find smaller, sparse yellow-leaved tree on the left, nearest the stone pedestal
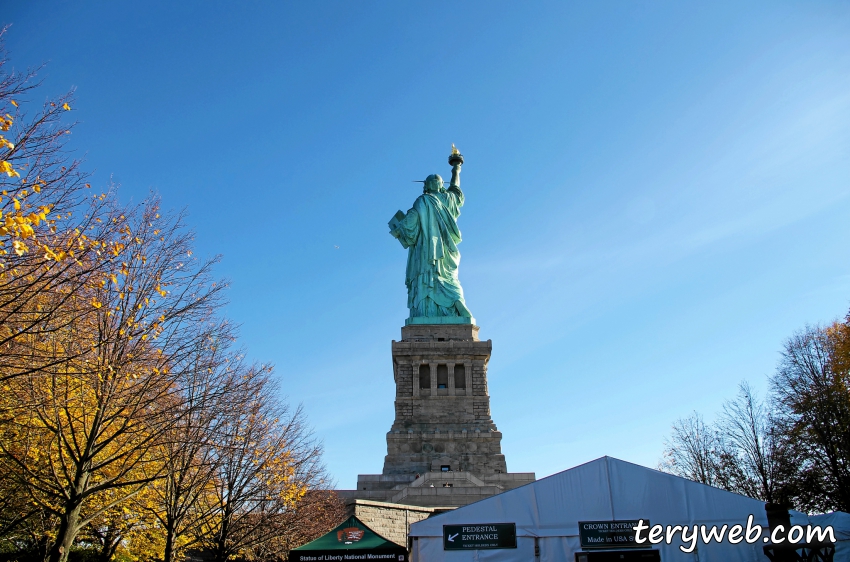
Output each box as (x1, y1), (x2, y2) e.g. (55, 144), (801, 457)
(200, 366), (326, 562)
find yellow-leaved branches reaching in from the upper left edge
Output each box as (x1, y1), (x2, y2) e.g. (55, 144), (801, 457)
(0, 26), (132, 388)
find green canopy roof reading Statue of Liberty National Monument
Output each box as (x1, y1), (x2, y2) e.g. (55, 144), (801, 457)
(289, 515), (407, 562)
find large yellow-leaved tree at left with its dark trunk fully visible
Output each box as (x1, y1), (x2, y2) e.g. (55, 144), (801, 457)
(0, 200), (223, 562)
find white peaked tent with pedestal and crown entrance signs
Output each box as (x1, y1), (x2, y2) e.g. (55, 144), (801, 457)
(410, 457), (808, 562)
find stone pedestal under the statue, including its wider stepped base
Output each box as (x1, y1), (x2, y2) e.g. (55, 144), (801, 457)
(341, 324), (534, 506)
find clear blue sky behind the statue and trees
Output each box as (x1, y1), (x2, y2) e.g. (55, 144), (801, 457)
(2, 0), (850, 487)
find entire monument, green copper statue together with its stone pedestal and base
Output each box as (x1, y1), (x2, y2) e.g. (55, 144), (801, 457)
(339, 146), (534, 507)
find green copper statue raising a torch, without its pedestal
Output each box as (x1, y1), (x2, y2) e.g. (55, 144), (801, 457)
(389, 145), (475, 324)
